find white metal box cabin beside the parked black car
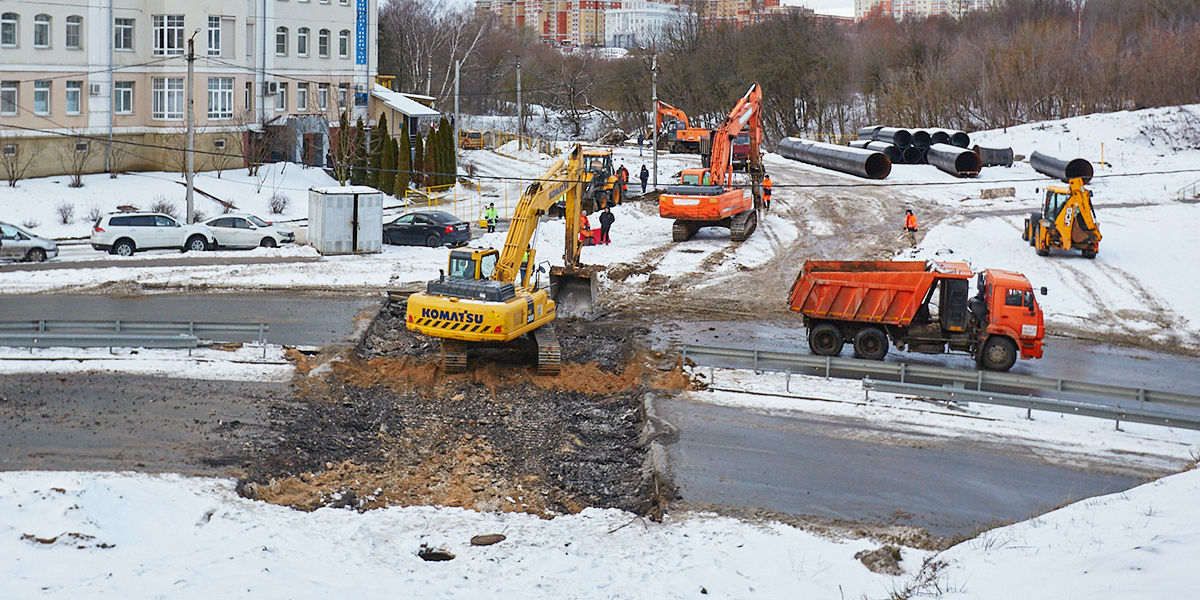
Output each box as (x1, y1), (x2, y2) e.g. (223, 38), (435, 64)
(308, 186), (383, 254)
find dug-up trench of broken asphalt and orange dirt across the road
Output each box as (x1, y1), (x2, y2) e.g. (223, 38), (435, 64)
(239, 310), (689, 517)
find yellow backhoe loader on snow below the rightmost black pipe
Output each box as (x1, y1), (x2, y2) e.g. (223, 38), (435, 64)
(1021, 178), (1100, 258)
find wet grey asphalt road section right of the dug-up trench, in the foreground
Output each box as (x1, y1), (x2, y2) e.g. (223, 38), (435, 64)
(658, 401), (1142, 538)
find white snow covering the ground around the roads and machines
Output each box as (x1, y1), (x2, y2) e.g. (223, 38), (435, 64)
(0, 107), (1200, 600)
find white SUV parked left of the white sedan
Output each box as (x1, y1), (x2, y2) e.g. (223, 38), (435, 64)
(91, 212), (216, 257)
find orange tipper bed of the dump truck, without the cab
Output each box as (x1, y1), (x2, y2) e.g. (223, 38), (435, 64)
(787, 260), (972, 326)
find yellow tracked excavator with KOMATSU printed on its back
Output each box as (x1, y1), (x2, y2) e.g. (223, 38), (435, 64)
(406, 144), (602, 374)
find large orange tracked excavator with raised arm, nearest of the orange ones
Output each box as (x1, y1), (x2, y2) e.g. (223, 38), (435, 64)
(659, 83), (763, 241)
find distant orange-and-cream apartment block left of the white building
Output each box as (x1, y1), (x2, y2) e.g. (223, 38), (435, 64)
(475, 0), (622, 46)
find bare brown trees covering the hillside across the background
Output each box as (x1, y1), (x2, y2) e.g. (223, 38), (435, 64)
(379, 0), (1200, 139)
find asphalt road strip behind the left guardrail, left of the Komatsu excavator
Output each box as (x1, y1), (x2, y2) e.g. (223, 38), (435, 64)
(0, 292), (383, 346)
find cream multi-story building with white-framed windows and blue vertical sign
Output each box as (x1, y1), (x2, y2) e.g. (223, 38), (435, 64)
(0, 0), (377, 176)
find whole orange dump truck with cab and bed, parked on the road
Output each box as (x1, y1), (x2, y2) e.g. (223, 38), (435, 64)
(787, 260), (1045, 371)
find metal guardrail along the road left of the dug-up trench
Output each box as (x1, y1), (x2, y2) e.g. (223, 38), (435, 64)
(0, 320), (270, 349)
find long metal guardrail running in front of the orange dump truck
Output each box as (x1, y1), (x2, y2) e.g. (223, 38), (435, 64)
(683, 344), (1200, 428)
